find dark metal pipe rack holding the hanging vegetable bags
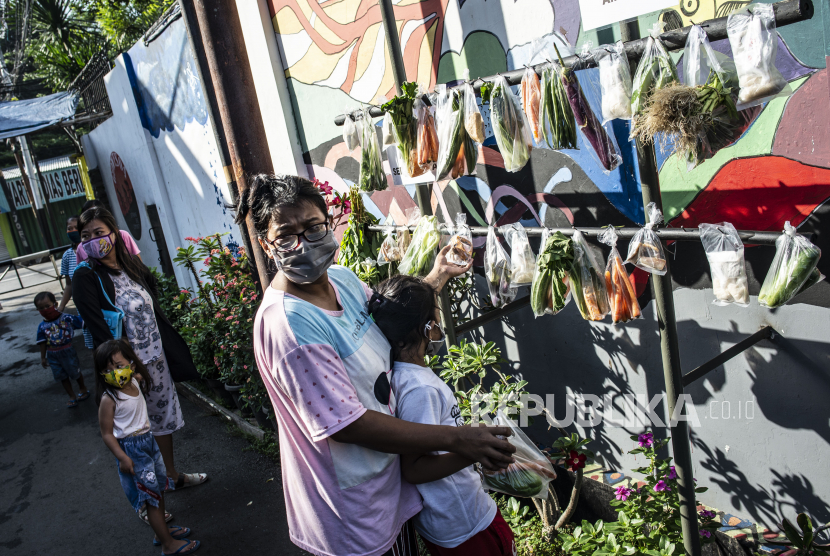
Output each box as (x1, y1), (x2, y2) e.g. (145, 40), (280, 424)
(348, 0), (814, 556)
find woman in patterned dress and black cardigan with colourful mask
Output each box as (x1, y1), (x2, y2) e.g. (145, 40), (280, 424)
(74, 207), (207, 524)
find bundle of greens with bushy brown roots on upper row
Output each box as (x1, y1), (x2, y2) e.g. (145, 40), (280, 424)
(631, 71), (741, 167)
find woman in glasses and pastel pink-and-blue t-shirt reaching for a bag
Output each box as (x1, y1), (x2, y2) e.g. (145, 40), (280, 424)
(236, 175), (515, 556)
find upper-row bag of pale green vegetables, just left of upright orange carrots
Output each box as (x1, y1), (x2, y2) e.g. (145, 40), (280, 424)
(490, 75), (533, 172)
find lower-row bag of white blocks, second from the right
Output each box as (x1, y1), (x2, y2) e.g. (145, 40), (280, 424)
(700, 222), (749, 307)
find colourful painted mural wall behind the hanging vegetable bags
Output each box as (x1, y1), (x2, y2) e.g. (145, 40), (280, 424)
(267, 0), (830, 527)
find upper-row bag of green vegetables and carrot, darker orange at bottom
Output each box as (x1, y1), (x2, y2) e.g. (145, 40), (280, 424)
(435, 85), (478, 180)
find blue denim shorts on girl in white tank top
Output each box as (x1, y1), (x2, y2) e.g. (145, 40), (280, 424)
(116, 432), (175, 512)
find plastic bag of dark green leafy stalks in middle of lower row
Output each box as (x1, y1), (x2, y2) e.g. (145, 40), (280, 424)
(530, 228), (574, 317)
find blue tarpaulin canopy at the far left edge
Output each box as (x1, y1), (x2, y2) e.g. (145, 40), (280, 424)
(0, 91), (79, 139)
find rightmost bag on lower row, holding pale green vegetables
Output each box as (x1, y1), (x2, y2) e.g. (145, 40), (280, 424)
(758, 221), (821, 309)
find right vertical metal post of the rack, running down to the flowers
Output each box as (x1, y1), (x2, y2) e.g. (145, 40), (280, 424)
(637, 140), (700, 556)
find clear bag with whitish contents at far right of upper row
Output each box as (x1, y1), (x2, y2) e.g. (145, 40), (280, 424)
(726, 4), (787, 110)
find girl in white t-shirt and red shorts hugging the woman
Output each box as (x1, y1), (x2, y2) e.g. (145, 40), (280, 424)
(369, 276), (516, 556)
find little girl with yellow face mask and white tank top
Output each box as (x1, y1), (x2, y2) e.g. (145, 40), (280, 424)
(95, 339), (200, 555)
